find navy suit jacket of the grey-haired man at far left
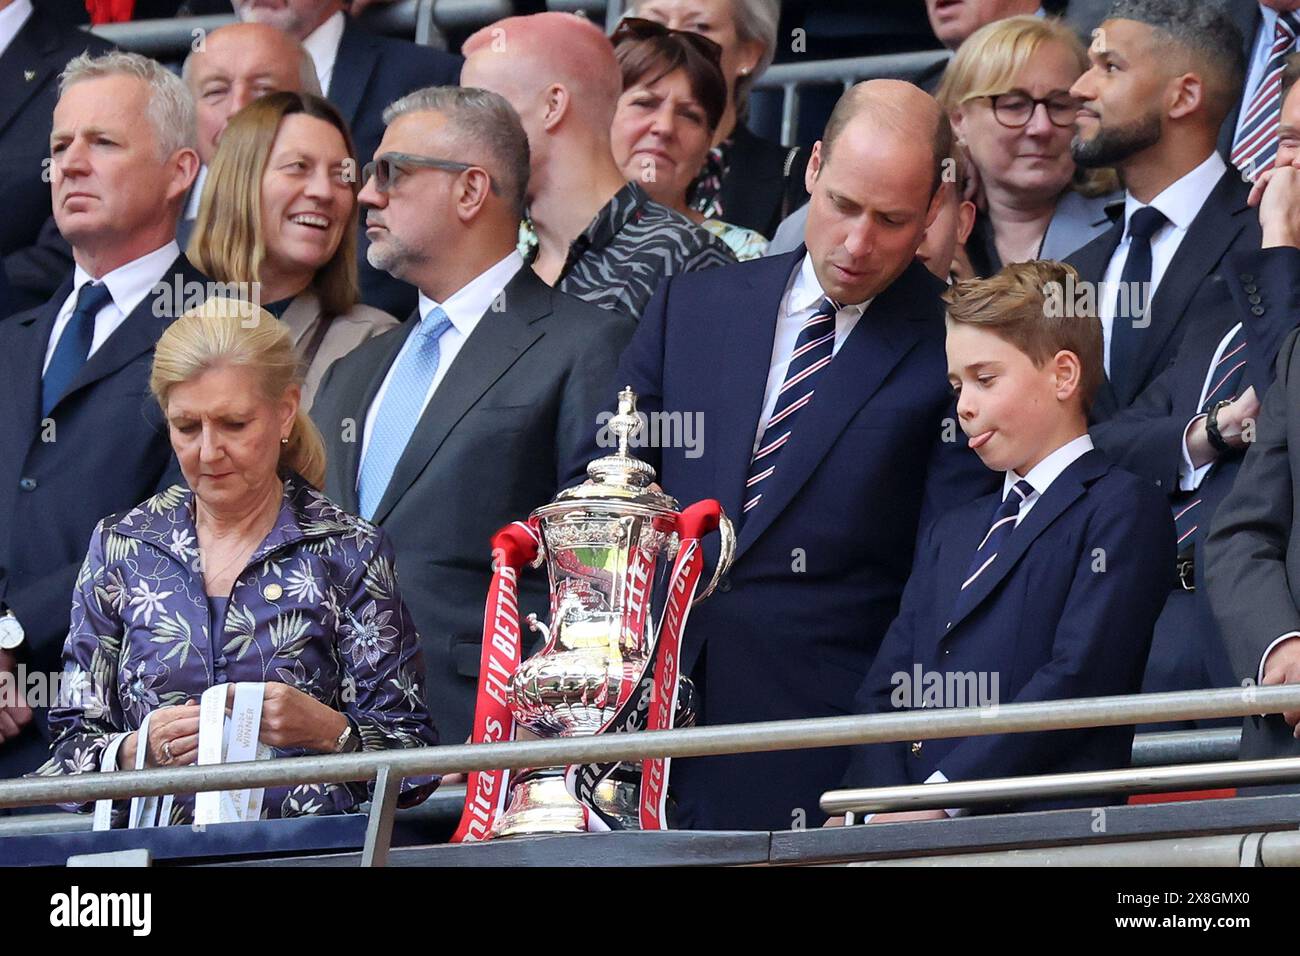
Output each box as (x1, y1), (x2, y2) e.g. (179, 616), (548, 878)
(0, 256), (196, 770)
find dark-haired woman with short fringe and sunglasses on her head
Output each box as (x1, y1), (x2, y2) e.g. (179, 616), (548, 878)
(610, 17), (767, 260)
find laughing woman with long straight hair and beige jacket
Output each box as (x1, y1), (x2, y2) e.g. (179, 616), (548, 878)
(187, 92), (398, 408)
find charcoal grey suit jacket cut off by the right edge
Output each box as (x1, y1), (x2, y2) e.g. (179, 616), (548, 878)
(1205, 325), (1300, 764)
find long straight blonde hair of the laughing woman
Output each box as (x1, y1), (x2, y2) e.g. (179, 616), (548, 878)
(186, 91), (360, 319)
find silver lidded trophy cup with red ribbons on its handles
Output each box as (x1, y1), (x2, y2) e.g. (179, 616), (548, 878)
(452, 388), (736, 842)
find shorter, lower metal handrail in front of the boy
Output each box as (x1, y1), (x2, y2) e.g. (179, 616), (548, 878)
(820, 757), (1300, 816)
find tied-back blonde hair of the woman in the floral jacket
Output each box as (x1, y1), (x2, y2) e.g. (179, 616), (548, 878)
(150, 295), (325, 489)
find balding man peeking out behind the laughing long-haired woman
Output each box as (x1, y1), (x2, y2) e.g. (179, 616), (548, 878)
(177, 23), (321, 248)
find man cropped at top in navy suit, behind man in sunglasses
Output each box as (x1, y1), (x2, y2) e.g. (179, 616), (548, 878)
(233, 0), (462, 315)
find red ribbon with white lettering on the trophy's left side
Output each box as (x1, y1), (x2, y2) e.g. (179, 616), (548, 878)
(451, 522), (541, 843)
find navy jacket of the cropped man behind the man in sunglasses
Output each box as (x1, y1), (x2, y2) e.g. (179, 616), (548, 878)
(329, 17), (462, 315)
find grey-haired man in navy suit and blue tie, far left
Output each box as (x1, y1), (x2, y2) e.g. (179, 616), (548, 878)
(0, 53), (203, 777)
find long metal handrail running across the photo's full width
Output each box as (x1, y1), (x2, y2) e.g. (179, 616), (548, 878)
(0, 684), (1300, 808)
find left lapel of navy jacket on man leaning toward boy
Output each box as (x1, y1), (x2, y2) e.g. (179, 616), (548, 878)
(709, 246), (805, 520)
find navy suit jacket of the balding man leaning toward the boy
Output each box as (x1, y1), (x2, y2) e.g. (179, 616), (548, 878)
(618, 248), (993, 830)
